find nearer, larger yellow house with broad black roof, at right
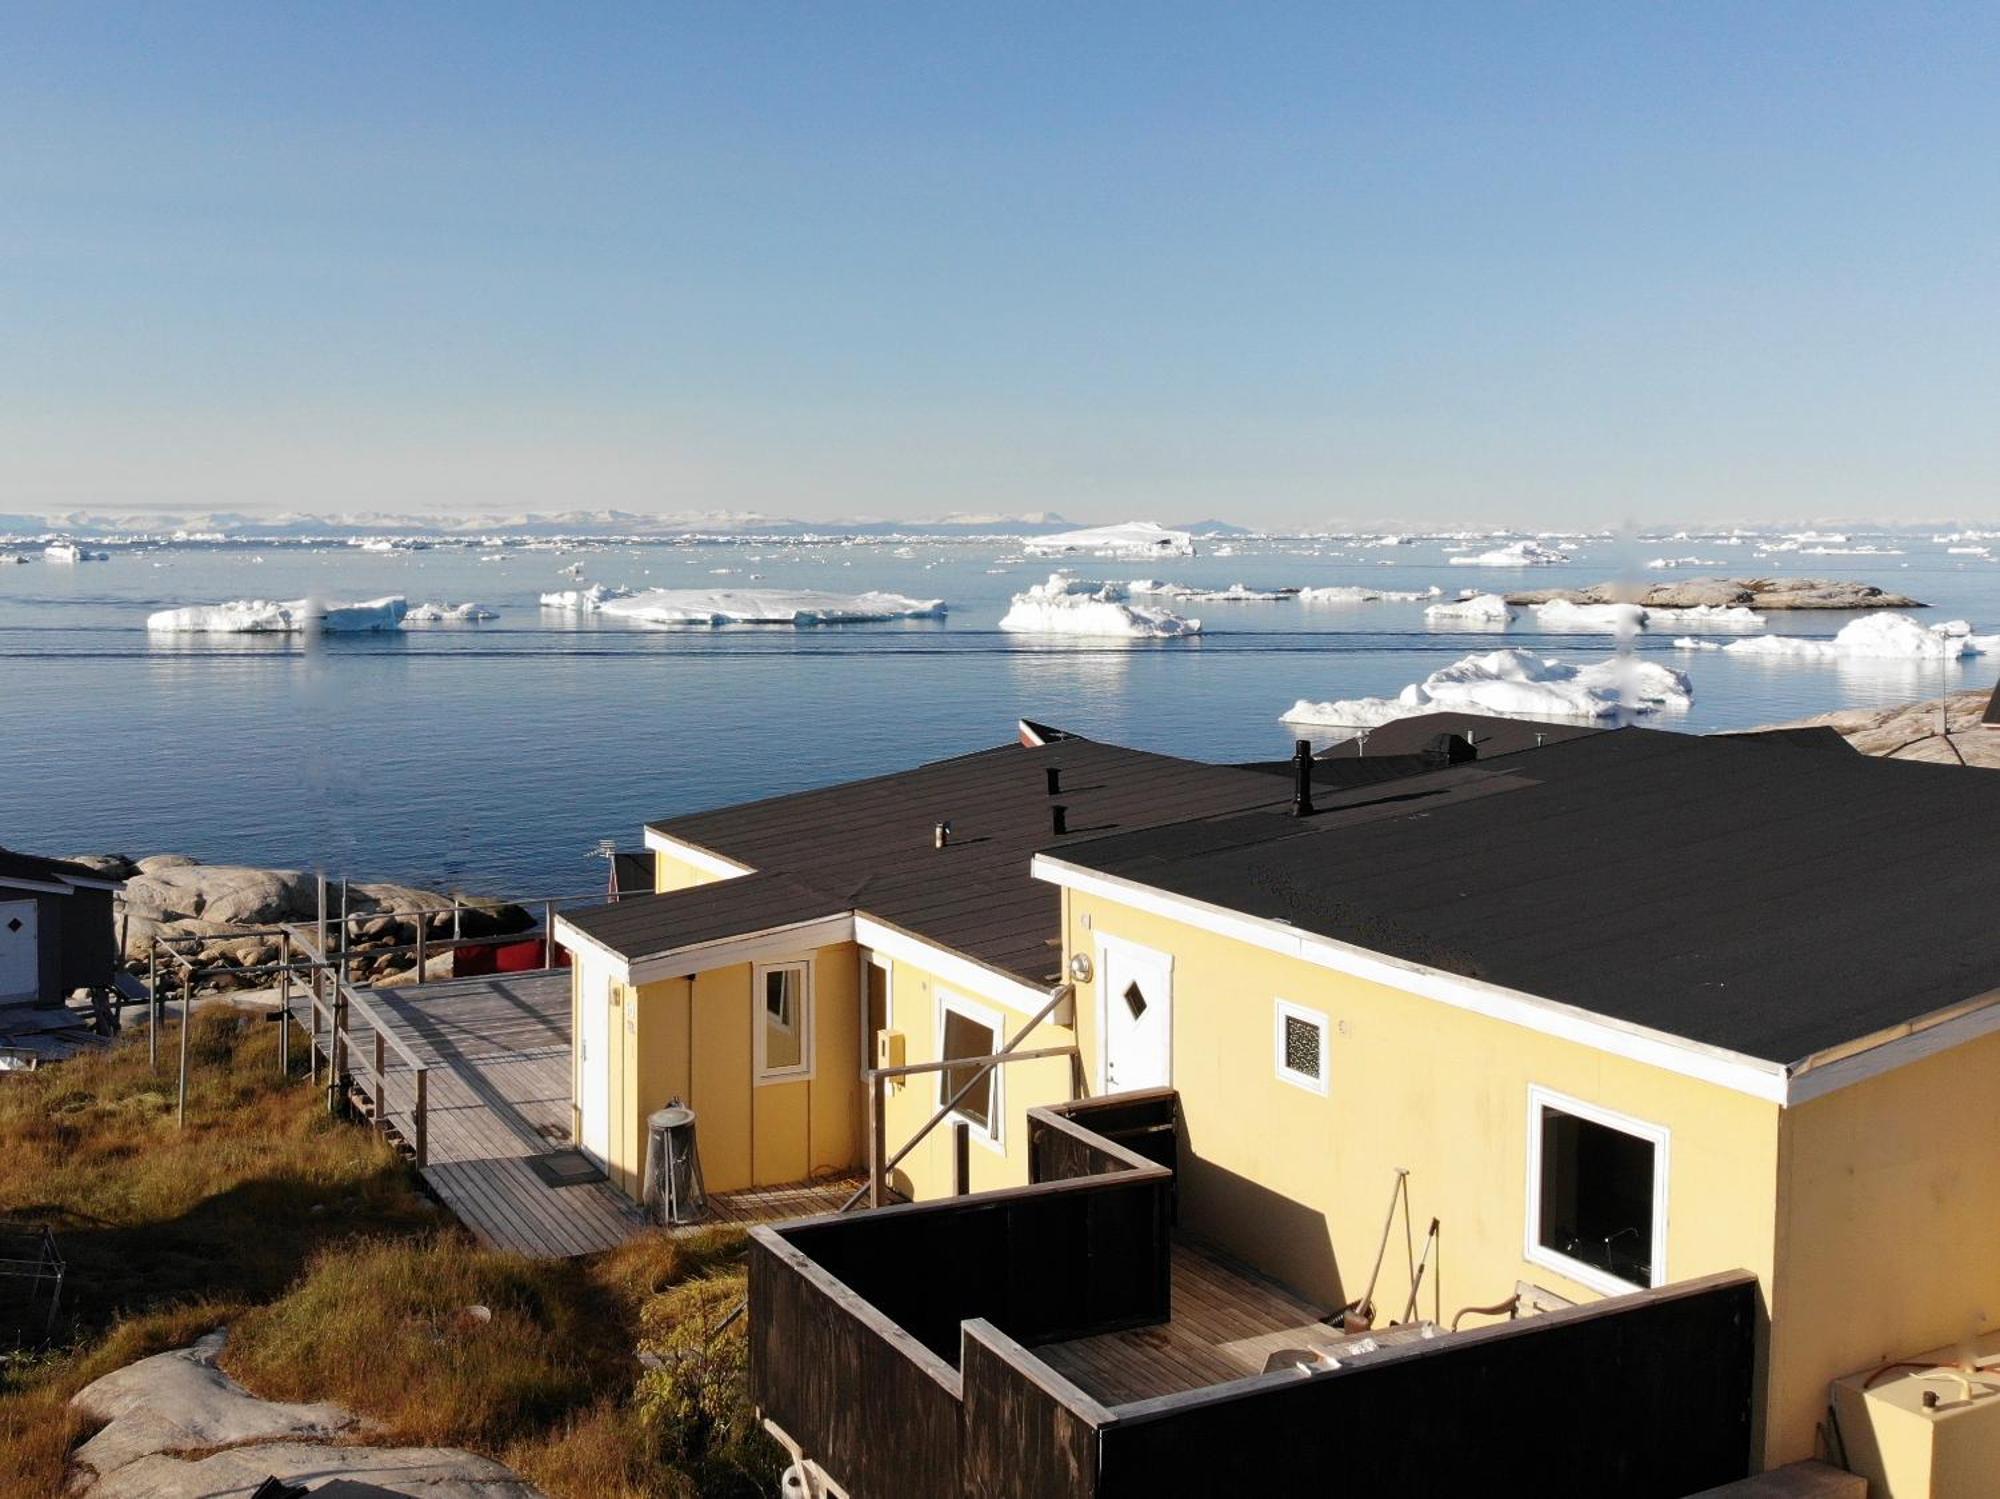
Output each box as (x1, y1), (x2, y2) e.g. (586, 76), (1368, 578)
(1034, 730), (2000, 1493)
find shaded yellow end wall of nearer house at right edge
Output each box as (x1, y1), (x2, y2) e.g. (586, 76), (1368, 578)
(1768, 1035), (2000, 1461)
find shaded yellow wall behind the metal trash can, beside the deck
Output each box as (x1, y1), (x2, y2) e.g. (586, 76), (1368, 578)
(610, 943), (862, 1195)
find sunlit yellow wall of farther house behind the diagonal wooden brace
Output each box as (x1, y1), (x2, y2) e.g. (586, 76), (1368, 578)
(862, 961), (1076, 1201)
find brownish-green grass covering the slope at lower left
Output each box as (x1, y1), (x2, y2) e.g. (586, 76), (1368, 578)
(0, 1007), (778, 1499)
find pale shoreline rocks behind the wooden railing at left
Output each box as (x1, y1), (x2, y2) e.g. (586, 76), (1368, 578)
(72, 853), (534, 989)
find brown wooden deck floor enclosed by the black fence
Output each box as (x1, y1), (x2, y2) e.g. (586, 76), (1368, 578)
(1034, 1241), (1342, 1405)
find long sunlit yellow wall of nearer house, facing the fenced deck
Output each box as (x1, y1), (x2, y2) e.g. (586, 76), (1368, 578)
(1066, 891), (1778, 1447)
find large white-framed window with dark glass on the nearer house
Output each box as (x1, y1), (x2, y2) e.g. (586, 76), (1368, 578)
(1526, 1087), (1672, 1295)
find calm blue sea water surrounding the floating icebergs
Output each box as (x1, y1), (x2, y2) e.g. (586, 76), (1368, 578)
(0, 532), (2000, 895)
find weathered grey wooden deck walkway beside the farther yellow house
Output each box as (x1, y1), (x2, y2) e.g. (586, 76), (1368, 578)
(354, 971), (862, 1259)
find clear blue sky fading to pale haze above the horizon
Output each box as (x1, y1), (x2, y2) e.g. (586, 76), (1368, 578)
(0, 0), (2000, 526)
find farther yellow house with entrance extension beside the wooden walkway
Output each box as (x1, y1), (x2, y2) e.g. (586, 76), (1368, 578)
(556, 726), (1286, 1201)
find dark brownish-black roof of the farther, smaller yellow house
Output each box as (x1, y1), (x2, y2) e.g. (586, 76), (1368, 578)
(566, 738), (1290, 985)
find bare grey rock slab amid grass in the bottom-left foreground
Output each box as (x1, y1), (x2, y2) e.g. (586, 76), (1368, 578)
(70, 1331), (546, 1499)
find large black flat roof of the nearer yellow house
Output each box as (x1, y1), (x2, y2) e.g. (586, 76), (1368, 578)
(1052, 730), (2000, 1065)
